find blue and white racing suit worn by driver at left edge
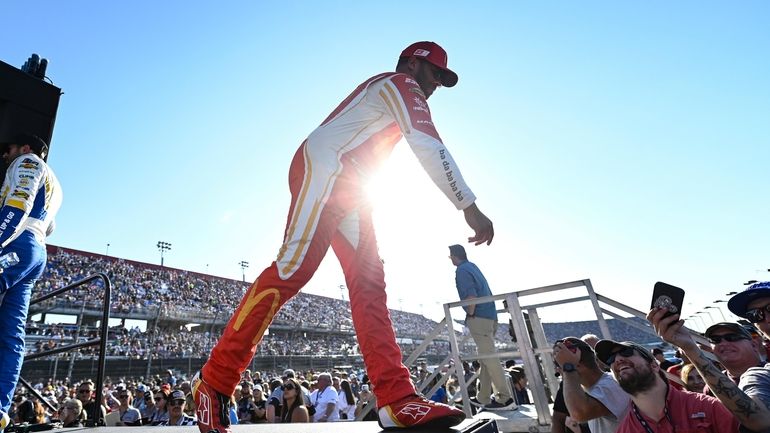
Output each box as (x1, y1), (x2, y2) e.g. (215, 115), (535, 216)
(0, 153), (62, 412)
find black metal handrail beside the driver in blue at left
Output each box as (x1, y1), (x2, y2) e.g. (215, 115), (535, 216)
(25, 272), (112, 427)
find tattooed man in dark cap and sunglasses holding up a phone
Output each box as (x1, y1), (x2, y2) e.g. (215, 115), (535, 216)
(647, 306), (770, 432)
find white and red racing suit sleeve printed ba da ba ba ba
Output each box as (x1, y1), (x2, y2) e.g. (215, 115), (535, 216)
(378, 74), (476, 210)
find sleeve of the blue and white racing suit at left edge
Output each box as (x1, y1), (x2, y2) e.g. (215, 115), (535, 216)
(0, 155), (44, 248)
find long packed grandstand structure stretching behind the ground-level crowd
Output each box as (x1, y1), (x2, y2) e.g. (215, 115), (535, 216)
(23, 245), (655, 380)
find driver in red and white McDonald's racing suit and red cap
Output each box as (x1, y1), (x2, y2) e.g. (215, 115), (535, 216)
(193, 42), (494, 433)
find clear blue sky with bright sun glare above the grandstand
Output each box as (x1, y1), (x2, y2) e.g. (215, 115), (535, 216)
(0, 0), (770, 328)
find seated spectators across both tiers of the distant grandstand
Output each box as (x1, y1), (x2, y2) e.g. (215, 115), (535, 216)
(27, 247), (664, 359)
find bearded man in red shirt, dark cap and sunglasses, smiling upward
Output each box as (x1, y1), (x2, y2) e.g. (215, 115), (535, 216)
(596, 340), (739, 433)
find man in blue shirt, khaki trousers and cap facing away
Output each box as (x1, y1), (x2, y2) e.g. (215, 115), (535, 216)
(449, 245), (517, 410)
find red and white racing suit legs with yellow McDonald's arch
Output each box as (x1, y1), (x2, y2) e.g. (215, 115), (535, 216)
(198, 145), (415, 406)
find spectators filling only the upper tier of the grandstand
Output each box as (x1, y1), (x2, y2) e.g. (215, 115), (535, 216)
(35, 247), (446, 337)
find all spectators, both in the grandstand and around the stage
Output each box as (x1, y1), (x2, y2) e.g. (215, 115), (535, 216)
(18, 250), (770, 433)
